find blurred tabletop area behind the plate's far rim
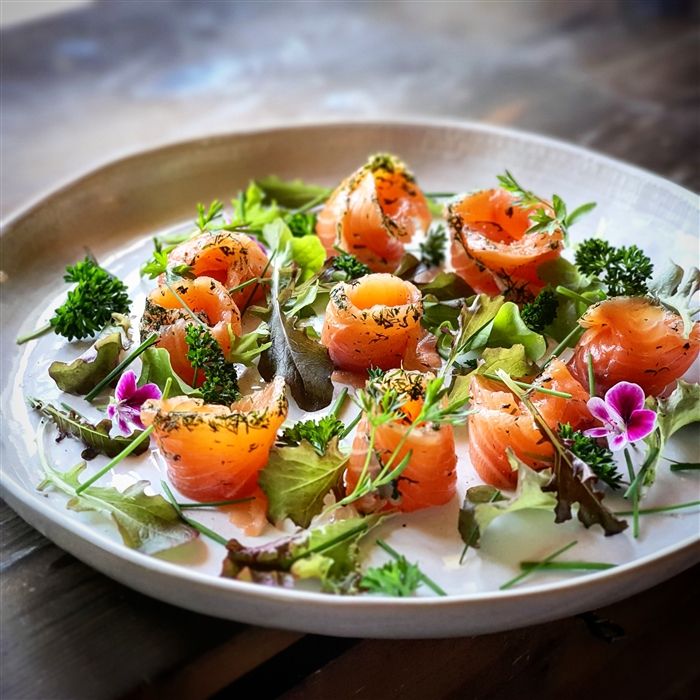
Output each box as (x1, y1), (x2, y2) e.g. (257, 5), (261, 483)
(0, 0), (700, 215)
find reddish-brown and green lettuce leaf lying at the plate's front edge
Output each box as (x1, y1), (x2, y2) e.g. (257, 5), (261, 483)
(221, 515), (381, 590)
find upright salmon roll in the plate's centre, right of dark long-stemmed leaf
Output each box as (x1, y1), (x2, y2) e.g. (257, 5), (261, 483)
(321, 273), (423, 372)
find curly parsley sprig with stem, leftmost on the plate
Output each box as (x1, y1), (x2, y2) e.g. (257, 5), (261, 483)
(17, 255), (131, 345)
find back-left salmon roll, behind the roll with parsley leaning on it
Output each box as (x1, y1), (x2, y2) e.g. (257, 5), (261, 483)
(165, 231), (270, 309)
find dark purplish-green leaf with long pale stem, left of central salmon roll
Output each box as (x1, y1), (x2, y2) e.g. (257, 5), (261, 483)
(258, 232), (333, 411)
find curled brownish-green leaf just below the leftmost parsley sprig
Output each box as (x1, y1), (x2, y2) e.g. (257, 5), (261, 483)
(49, 314), (130, 396)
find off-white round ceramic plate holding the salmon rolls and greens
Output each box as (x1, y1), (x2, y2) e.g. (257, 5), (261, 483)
(2, 122), (700, 637)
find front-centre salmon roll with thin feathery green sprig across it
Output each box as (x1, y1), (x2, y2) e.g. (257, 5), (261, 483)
(345, 369), (457, 513)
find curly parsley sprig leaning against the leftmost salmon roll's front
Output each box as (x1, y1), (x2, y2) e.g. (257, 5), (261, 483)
(185, 323), (241, 405)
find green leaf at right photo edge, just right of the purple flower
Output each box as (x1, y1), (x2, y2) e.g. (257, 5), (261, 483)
(640, 379), (700, 486)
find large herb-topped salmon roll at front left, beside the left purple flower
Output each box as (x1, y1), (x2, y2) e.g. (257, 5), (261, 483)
(141, 377), (287, 501)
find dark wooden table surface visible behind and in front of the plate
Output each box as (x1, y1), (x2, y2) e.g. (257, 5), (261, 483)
(0, 0), (700, 700)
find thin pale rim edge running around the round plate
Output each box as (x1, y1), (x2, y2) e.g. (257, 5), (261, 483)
(0, 117), (700, 620)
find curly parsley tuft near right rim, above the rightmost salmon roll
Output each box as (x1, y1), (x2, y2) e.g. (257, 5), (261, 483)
(575, 238), (654, 297)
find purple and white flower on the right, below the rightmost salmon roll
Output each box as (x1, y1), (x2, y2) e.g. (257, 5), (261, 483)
(585, 382), (656, 451)
